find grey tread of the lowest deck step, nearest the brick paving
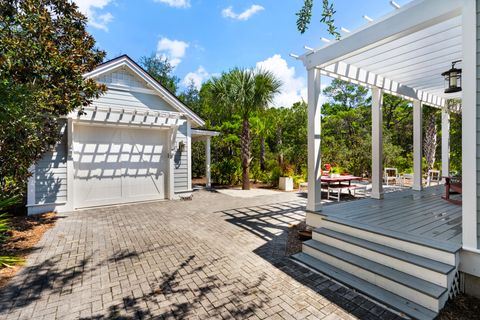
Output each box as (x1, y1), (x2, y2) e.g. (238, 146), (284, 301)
(292, 253), (437, 320)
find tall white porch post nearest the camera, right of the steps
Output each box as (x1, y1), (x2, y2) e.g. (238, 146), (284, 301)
(462, 1), (480, 250)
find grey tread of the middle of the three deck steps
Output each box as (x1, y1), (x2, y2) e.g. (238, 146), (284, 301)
(303, 240), (447, 299)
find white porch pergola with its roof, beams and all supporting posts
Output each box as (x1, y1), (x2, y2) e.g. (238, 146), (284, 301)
(298, 0), (477, 250)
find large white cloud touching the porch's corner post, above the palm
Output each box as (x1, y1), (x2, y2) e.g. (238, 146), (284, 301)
(256, 54), (307, 108)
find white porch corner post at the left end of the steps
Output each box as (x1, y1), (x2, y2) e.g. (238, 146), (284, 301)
(307, 69), (322, 211)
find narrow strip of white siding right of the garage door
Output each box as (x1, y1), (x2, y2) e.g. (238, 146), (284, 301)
(173, 122), (189, 192)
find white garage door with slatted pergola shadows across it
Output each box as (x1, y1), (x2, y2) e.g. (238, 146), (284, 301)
(73, 126), (168, 208)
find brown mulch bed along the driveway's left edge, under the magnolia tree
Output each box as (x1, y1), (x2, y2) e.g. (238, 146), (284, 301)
(0, 213), (57, 287)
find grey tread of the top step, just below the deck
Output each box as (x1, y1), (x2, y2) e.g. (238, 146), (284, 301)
(314, 228), (455, 274)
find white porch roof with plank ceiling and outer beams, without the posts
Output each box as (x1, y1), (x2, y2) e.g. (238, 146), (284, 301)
(300, 0), (463, 107)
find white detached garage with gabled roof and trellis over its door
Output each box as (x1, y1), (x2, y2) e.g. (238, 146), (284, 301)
(27, 55), (217, 214)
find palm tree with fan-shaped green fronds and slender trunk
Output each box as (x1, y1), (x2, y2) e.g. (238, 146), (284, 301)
(212, 68), (282, 190)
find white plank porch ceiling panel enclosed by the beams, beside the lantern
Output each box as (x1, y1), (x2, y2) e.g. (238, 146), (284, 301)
(343, 16), (462, 98)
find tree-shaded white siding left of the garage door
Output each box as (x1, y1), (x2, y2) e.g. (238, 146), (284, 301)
(35, 123), (67, 204)
